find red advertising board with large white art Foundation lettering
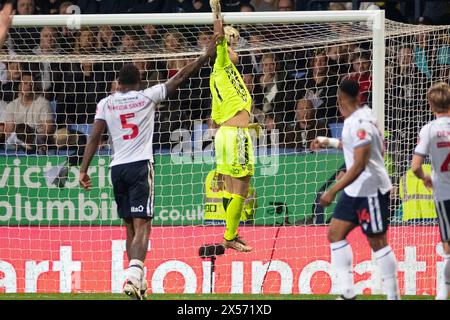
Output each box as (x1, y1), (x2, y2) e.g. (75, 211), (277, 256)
(0, 226), (443, 295)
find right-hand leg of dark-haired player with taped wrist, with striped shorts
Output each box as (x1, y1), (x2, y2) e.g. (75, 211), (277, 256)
(360, 192), (400, 300)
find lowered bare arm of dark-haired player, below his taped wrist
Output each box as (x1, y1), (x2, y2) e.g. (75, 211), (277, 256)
(320, 144), (370, 207)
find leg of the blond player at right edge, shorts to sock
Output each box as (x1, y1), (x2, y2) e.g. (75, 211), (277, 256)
(436, 200), (450, 300)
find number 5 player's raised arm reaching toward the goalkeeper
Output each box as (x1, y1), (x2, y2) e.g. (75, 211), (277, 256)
(166, 35), (218, 96)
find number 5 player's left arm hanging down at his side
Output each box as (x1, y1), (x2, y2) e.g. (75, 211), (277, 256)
(79, 120), (106, 190)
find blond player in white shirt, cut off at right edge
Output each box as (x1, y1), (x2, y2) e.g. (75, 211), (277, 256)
(412, 82), (450, 300)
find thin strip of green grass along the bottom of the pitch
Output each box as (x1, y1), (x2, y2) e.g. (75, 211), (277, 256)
(0, 293), (434, 300)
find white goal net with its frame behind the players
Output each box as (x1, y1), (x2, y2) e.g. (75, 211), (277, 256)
(0, 11), (450, 294)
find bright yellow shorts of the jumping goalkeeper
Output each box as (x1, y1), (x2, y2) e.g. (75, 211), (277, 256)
(214, 126), (255, 178)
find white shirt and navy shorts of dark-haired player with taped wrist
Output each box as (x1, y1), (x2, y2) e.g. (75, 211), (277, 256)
(333, 105), (392, 235)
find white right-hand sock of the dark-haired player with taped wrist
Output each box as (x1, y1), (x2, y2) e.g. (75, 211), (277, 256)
(374, 246), (400, 300)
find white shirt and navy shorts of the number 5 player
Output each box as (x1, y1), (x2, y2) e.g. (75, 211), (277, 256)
(95, 84), (167, 219)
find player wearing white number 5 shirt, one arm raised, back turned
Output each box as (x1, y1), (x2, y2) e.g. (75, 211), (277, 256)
(79, 37), (217, 300)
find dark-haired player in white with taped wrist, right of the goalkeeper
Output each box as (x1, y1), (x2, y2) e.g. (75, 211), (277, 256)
(311, 80), (400, 300)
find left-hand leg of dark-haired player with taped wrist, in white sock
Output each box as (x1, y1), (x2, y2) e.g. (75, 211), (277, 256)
(328, 215), (356, 300)
